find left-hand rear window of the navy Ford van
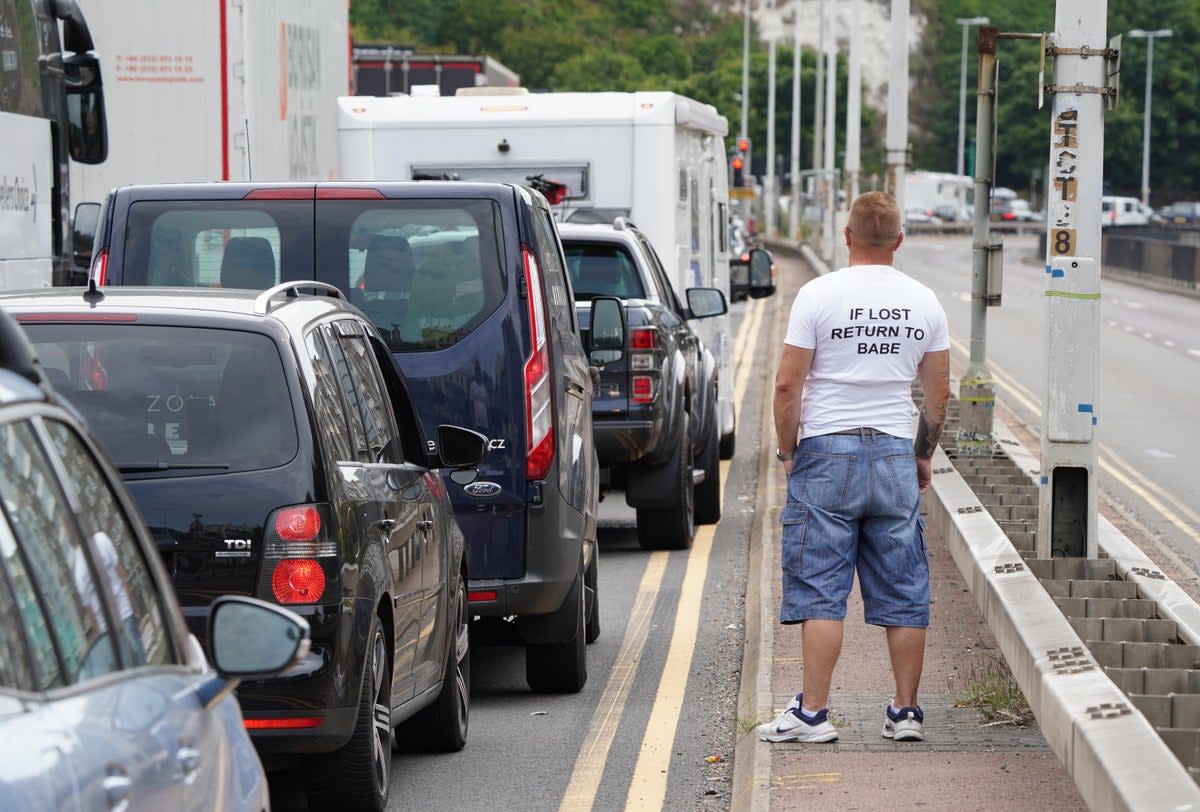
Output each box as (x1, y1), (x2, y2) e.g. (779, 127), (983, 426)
(119, 200), (313, 289)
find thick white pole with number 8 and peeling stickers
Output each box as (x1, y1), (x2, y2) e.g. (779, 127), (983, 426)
(1037, 0), (1112, 558)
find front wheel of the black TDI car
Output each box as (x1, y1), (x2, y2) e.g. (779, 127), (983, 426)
(403, 572), (470, 753)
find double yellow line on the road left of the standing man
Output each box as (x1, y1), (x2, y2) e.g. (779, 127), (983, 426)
(558, 300), (764, 812)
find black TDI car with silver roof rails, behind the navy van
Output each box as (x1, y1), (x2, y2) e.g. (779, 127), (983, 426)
(0, 282), (487, 810)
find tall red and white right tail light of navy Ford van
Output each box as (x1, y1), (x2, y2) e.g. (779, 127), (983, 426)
(521, 246), (554, 480)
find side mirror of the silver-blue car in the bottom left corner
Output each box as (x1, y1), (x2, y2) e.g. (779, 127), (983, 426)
(209, 595), (310, 679)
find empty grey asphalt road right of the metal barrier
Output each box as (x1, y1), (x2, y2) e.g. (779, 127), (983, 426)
(898, 235), (1200, 599)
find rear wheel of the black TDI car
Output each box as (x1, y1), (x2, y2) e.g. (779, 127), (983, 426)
(308, 615), (392, 812)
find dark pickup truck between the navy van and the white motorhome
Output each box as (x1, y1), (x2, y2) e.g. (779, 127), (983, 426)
(559, 217), (727, 549)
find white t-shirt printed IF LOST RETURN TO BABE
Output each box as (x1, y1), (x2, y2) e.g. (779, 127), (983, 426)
(784, 265), (950, 438)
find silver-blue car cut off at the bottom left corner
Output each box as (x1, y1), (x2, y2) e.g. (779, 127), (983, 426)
(0, 311), (310, 812)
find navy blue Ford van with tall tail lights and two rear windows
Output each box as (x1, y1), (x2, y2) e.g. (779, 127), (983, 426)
(81, 181), (600, 693)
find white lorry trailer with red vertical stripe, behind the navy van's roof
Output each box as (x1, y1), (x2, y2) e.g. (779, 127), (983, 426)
(71, 0), (350, 202)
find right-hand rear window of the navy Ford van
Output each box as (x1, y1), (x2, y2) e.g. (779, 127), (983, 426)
(316, 198), (508, 353)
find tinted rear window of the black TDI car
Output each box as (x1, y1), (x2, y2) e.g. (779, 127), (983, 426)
(23, 320), (298, 475)
